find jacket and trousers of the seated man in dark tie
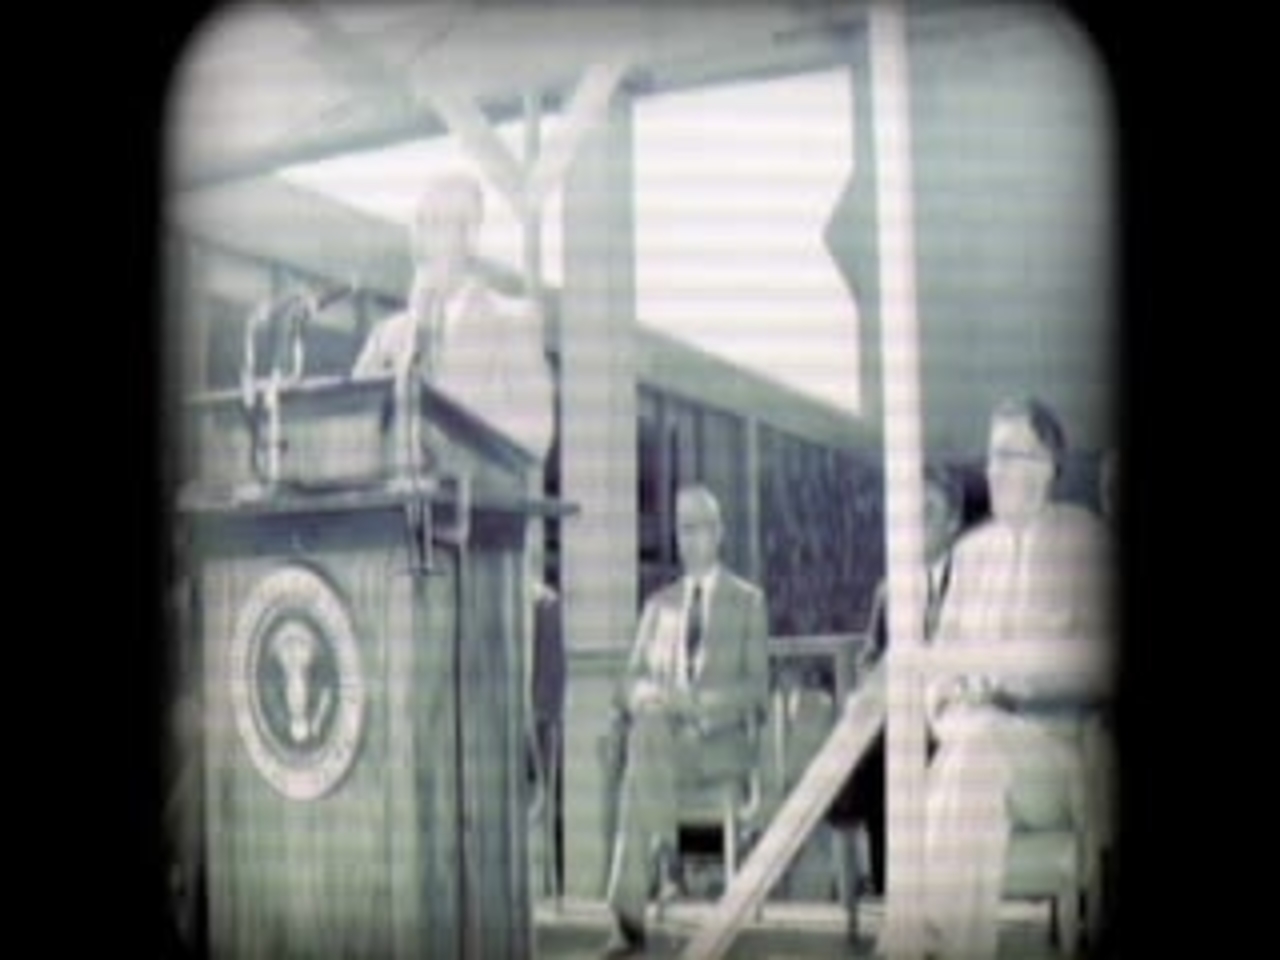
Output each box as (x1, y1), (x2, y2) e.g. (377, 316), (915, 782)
(608, 567), (769, 924)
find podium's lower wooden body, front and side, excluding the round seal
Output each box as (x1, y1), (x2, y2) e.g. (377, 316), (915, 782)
(194, 511), (531, 959)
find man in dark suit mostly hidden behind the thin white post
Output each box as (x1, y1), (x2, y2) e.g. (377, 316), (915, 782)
(827, 466), (964, 895)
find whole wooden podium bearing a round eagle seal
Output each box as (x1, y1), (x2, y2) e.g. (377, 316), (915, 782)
(180, 378), (567, 960)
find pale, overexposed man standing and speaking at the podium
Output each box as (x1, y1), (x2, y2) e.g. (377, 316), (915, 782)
(352, 174), (554, 461)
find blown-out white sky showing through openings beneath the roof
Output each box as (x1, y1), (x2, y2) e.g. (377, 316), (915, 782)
(280, 70), (859, 411)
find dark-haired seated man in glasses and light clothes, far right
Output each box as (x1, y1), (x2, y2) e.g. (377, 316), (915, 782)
(924, 399), (1110, 960)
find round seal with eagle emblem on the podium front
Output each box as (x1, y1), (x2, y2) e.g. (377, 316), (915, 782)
(229, 564), (366, 800)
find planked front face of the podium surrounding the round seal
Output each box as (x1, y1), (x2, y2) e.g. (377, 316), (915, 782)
(204, 537), (392, 957)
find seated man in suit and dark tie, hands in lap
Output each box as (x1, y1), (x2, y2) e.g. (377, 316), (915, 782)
(605, 486), (769, 956)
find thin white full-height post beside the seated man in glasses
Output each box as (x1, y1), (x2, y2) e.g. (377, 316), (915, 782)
(868, 0), (925, 960)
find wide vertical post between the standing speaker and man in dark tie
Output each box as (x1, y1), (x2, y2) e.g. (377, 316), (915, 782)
(561, 90), (639, 897)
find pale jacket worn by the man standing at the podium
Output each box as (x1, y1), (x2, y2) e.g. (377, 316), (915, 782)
(352, 279), (556, 460)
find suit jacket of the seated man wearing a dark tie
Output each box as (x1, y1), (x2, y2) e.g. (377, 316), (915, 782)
(617, 567), (769, 741)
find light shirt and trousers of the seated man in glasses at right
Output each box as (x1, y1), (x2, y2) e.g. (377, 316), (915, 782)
(924, 504), (1111, 960)
